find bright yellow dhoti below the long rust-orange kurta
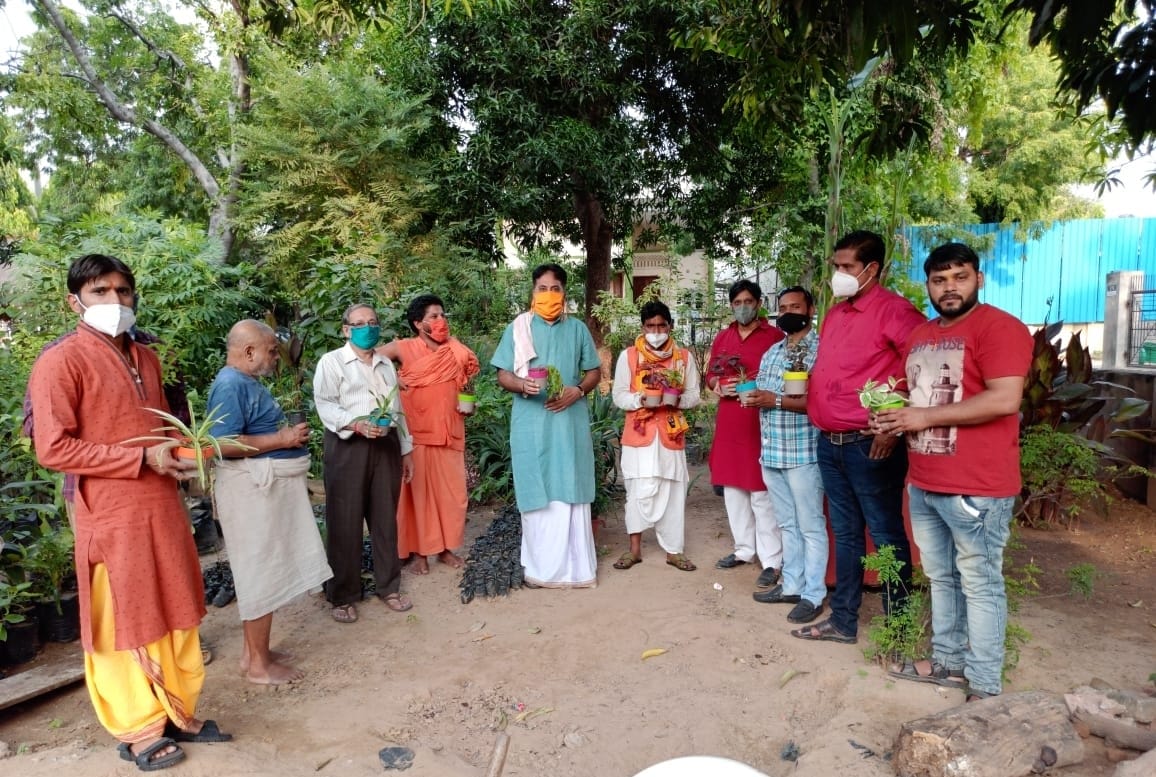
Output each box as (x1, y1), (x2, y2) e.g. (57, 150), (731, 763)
(84, 564), (205, 743)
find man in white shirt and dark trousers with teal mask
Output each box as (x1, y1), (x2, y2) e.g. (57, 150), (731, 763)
(313, 303), (414, 623)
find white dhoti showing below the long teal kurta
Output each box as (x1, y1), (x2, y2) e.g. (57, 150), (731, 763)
(521, 502), (598, 589)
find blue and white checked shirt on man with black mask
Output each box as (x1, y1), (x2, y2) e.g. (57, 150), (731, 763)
(757, 327), (818, 469)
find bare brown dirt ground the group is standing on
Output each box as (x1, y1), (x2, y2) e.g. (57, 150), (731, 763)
(0, 467), (1156, 777)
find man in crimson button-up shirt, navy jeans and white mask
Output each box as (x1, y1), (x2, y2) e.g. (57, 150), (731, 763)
(791, 230), (926, 643)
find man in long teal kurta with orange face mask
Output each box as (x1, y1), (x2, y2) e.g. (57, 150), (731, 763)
(490, 264), (601, 587)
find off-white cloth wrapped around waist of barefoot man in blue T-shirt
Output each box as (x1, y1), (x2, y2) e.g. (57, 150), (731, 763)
(213, 456), (333, 621)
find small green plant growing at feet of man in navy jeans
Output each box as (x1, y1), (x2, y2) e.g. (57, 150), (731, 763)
(862, 545), (931, 663)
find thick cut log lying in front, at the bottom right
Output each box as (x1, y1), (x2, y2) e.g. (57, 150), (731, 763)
(894, 690), (1084, 777)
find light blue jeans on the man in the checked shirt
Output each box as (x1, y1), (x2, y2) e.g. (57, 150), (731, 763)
(763, 464), (828, 607)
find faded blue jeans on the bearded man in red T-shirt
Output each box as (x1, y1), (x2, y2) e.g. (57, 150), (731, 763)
(907, 486), (1015, 694)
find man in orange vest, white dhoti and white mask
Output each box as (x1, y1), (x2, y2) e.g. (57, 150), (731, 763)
(614, 301), (699, 572)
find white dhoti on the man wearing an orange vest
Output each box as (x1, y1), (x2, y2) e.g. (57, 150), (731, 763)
(621, 435), (690, 554)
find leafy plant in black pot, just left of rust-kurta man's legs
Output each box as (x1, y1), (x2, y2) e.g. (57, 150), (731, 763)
(25, 519), (80, 642)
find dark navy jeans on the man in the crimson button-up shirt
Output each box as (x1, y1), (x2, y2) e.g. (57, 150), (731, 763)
(818, 436), (911, 636)
